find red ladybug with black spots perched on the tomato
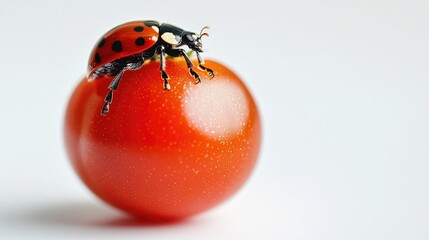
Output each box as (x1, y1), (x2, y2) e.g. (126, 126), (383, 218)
(88, 20), (214, 116)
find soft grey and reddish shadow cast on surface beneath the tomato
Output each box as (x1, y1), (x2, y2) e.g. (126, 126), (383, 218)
(21, 202), (207, 228)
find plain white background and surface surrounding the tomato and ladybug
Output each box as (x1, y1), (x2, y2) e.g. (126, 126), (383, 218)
(0, 0), (429, 240)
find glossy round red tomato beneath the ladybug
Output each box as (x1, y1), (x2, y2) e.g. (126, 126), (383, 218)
(64, 59), (261, 219)
